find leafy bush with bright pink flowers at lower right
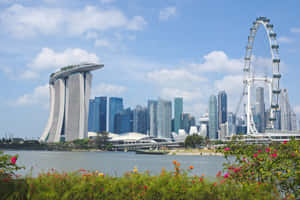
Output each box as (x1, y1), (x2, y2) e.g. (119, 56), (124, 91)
(223, 140), (300, 198)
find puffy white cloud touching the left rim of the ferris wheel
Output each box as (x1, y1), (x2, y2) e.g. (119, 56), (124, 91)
(190, 51), (243, 73)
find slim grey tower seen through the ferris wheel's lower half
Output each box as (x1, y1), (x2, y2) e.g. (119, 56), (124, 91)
(255, 87), (266, 133)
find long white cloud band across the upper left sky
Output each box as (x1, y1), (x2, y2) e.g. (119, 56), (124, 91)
(0, 4), (147, 38)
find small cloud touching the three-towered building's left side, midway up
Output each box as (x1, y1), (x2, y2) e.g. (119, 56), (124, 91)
(16, 84), (49, 108)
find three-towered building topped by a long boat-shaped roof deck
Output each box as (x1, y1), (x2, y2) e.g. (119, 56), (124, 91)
(40, 63), (103, 142)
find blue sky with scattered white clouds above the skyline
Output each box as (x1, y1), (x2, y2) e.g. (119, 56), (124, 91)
(0, 0), (300, 138)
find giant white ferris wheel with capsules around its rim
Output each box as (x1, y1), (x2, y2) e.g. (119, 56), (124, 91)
(243, 17), (281, 135)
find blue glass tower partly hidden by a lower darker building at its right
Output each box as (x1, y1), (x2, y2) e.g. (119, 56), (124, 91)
(108, 97), (123, 133)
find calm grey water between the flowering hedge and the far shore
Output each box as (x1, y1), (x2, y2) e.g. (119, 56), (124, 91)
(5, 151), (225, 177)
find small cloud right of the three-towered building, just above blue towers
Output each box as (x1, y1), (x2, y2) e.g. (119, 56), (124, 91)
(92, 83), (127, 97)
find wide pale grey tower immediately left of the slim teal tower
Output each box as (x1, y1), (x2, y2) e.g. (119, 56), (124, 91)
(157, 99), (172, 138)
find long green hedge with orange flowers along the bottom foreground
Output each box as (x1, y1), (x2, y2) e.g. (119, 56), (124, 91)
(0, 161), (288, 200)
